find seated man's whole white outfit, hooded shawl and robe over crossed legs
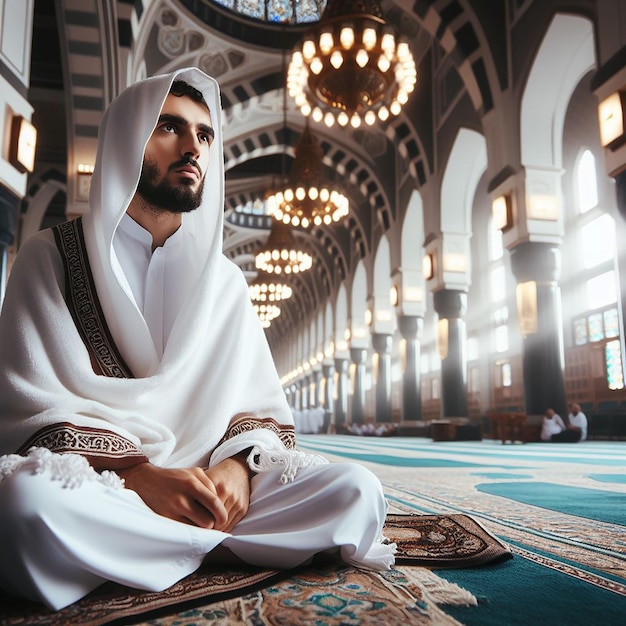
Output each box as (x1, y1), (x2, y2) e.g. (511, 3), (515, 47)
(0, 68), (393, 609)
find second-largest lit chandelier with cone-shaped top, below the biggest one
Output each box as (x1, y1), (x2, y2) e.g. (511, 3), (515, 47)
(267, 120), (349, 228)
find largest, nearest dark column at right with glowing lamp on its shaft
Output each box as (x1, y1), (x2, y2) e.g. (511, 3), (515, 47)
(511, 242), (567, 415)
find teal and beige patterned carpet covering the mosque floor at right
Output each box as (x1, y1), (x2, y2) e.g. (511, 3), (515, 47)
(299, 435), (626, 626)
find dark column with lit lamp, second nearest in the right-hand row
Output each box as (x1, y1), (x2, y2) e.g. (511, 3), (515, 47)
(433, 289), (468, 417)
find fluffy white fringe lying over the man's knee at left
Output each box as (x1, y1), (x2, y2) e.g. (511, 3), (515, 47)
(0, 448), (124, 489)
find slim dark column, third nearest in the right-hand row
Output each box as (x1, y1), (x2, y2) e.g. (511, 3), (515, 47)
(398, 315), (424, 420)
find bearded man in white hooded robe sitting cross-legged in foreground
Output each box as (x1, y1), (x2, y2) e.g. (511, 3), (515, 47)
(0, 68), (395, 609)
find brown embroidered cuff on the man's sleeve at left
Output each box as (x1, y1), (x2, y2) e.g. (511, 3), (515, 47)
(18, 422), (148, 467)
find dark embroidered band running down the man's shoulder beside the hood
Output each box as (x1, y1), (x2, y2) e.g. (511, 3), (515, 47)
(52, 217), (133, 378)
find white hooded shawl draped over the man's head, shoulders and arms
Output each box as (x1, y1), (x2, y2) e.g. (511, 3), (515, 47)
(0, 68), (304, 474)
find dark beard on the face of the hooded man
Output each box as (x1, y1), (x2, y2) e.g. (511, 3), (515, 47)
(137, 159), (204, 213)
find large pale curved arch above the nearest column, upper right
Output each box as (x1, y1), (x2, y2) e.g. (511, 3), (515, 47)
(520, 13), (596, 168)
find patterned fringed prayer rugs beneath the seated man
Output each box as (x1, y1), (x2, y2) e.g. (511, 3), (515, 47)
(0, 514), (511, 626)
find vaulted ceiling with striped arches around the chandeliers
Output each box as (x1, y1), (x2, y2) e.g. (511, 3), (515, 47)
(29, 0), (506, 343)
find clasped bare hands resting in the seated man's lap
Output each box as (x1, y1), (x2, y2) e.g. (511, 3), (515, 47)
(117, 453), (250, 532)
